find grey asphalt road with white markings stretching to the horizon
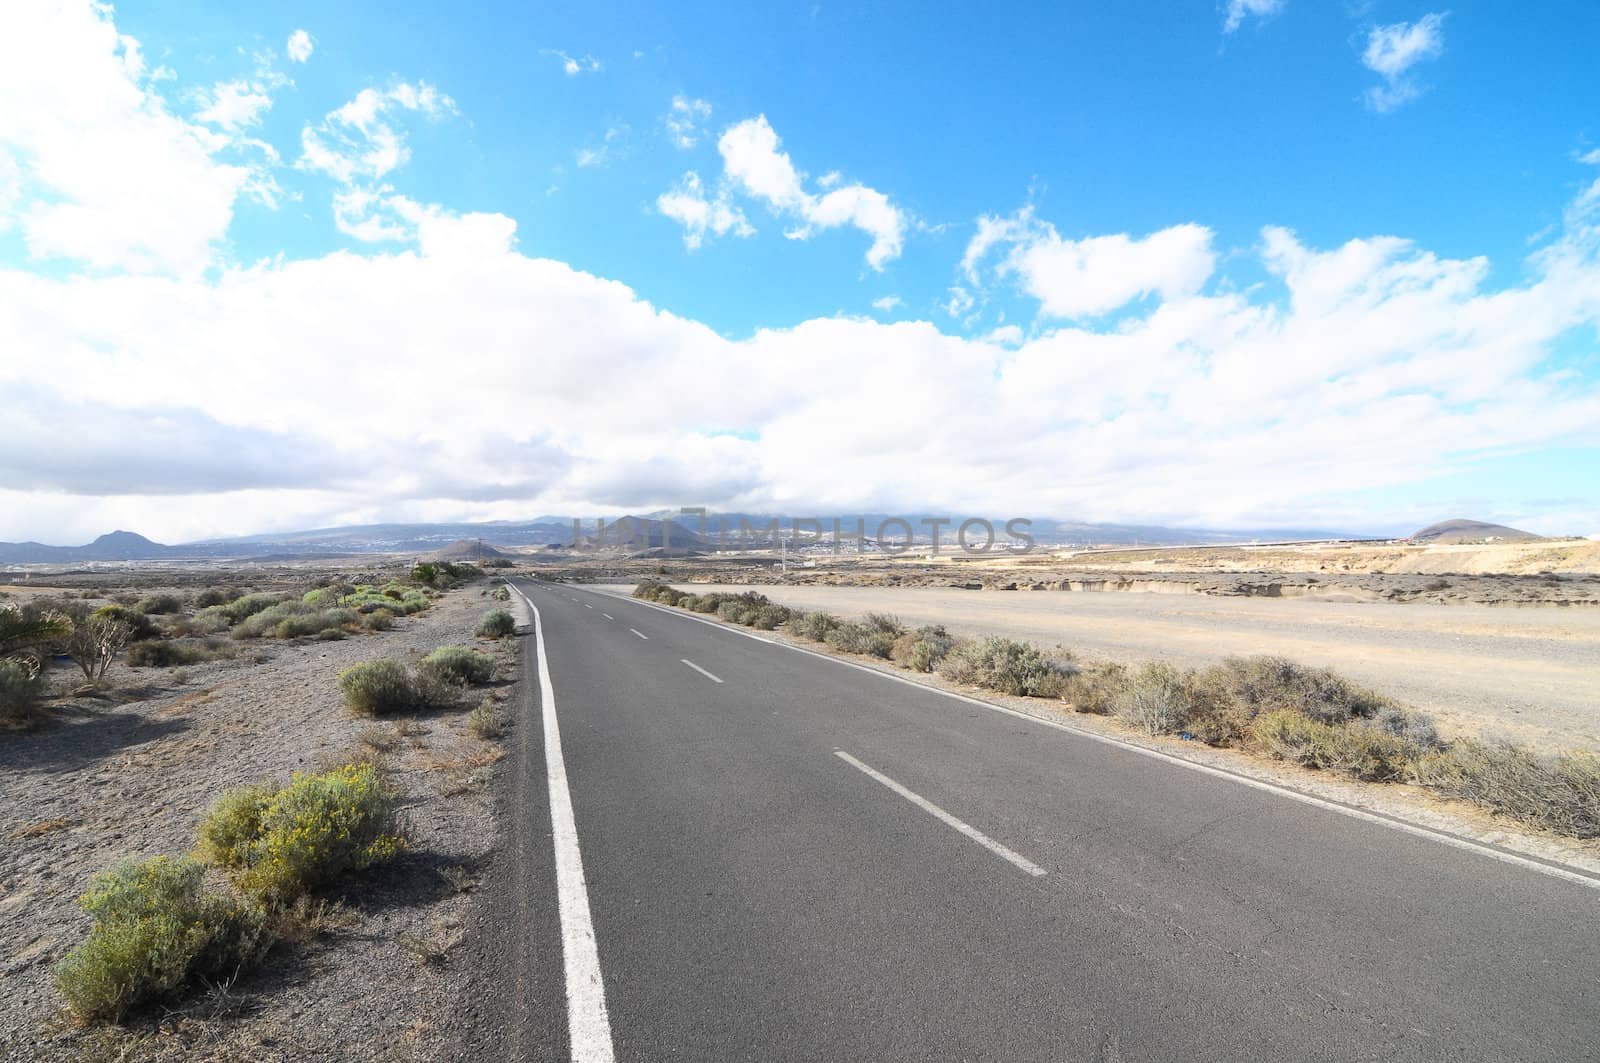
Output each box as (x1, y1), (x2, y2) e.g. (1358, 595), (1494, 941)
(478, 583), (1600, 1063)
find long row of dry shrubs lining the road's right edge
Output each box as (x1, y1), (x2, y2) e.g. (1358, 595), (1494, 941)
(634, 581), (1600, 839)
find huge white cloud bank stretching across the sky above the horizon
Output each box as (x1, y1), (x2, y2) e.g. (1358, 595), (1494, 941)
(9, 168), (1600, 538)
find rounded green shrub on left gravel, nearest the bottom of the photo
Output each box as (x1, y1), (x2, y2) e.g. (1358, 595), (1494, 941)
(56, 856), (272, 1021)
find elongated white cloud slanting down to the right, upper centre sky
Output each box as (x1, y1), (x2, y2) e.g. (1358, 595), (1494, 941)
(717, 115), (906, 271)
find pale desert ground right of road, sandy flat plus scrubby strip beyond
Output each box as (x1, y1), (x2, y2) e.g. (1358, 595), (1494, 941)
(570, 541), (1600, 749)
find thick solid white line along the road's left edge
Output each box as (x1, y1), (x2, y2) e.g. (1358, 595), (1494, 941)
(517, 589), (614, 1063)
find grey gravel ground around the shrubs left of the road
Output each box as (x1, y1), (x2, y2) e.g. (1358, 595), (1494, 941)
(0, 584), (517, 1060)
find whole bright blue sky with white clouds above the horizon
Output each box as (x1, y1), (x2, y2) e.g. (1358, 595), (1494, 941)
(0, 0), (1600, 536)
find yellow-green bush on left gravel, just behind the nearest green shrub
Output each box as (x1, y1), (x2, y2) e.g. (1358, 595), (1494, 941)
(200, 764), (405, 903)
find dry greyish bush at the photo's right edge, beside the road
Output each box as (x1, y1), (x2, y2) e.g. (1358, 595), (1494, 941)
(1414, 740), (1600, 839)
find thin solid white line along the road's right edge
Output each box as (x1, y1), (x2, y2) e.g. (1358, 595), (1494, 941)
(569, 588), (1600, 890)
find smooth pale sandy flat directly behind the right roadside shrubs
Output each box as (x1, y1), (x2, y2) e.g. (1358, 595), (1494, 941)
(604, 583), (1600, 749)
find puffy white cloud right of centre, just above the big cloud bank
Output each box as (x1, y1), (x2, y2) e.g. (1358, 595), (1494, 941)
(962, 207), (1216, 317)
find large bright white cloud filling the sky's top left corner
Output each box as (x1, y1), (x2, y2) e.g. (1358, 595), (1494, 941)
(0, 3), (250, 272)
